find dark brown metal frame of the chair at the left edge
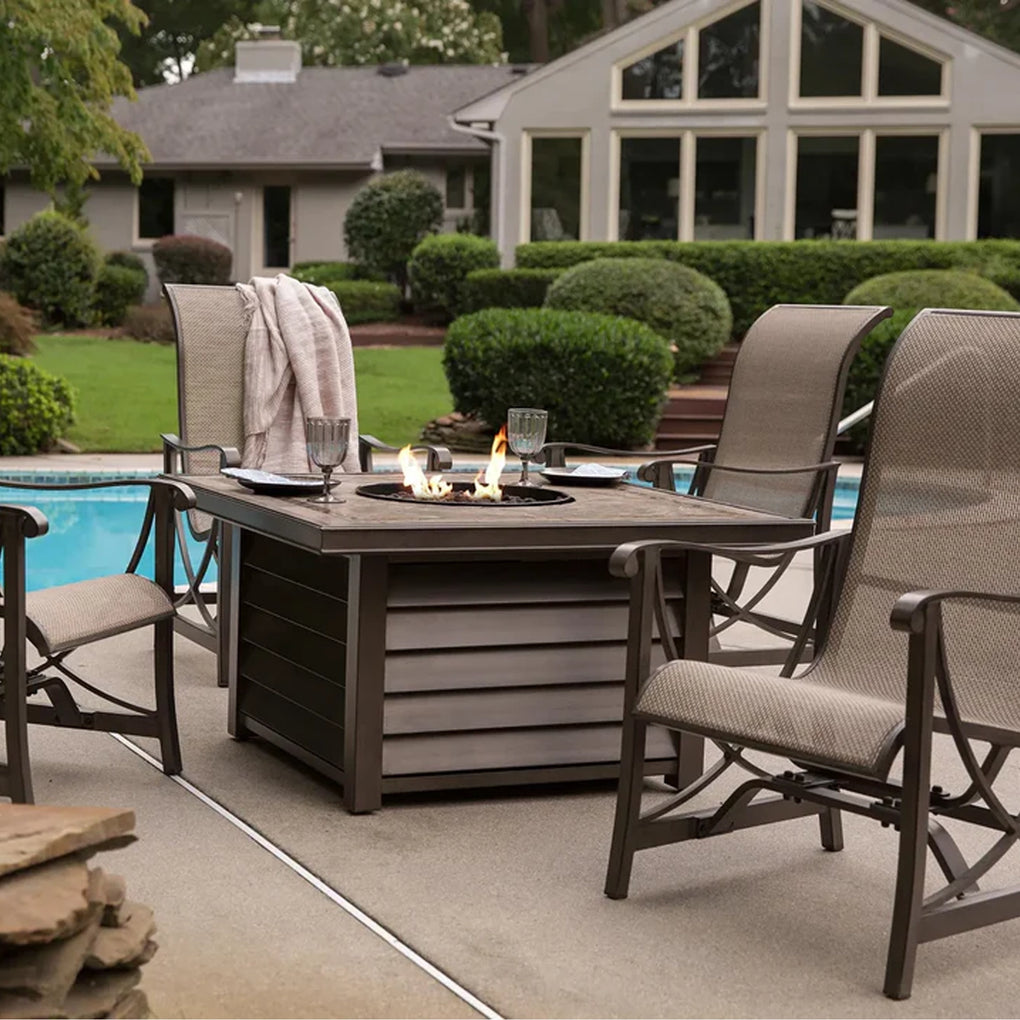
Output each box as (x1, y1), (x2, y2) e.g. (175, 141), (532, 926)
(0, 478), (195, 803)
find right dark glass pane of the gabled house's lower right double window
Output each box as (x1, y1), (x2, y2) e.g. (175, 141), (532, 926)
(872, 135), (938, 241)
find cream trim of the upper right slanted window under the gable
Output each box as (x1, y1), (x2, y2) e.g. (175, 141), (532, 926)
(788, 0), (953, 110)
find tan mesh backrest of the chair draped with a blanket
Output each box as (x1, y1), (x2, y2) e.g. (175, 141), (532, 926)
(164, 284), (245, 474)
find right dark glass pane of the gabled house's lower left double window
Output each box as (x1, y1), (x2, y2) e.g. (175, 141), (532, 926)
(695, 138), (758, 241)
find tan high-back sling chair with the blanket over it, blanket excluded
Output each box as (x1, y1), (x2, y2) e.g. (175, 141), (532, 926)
(162, 284), (451, 649)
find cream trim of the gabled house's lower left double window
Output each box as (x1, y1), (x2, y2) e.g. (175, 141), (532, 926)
(606, 128), (765, 241)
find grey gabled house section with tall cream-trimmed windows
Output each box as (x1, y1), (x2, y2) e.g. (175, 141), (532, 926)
(454, 0), (1020, 264)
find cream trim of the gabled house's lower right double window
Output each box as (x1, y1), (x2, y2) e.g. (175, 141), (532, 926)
(782, 124), (950, 241)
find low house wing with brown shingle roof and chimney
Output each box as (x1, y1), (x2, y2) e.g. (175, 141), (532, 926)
(0, 33), (527, 294)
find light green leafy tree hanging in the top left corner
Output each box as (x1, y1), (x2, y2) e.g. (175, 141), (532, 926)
(0, 0), (149, 195)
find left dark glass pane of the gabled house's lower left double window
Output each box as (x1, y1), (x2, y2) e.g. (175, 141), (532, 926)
(618, 138), (680, 241)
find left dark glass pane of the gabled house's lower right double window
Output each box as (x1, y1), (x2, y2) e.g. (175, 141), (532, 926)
(794, 136), (861, 239)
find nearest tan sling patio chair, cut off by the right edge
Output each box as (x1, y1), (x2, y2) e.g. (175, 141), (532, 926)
(606, 310), (1020, 999)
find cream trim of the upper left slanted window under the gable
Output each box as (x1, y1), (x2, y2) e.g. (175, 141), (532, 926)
(609, 0), (772, 113)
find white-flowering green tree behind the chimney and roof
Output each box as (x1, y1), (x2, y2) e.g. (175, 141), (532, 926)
(196, 0), (503, 70)
